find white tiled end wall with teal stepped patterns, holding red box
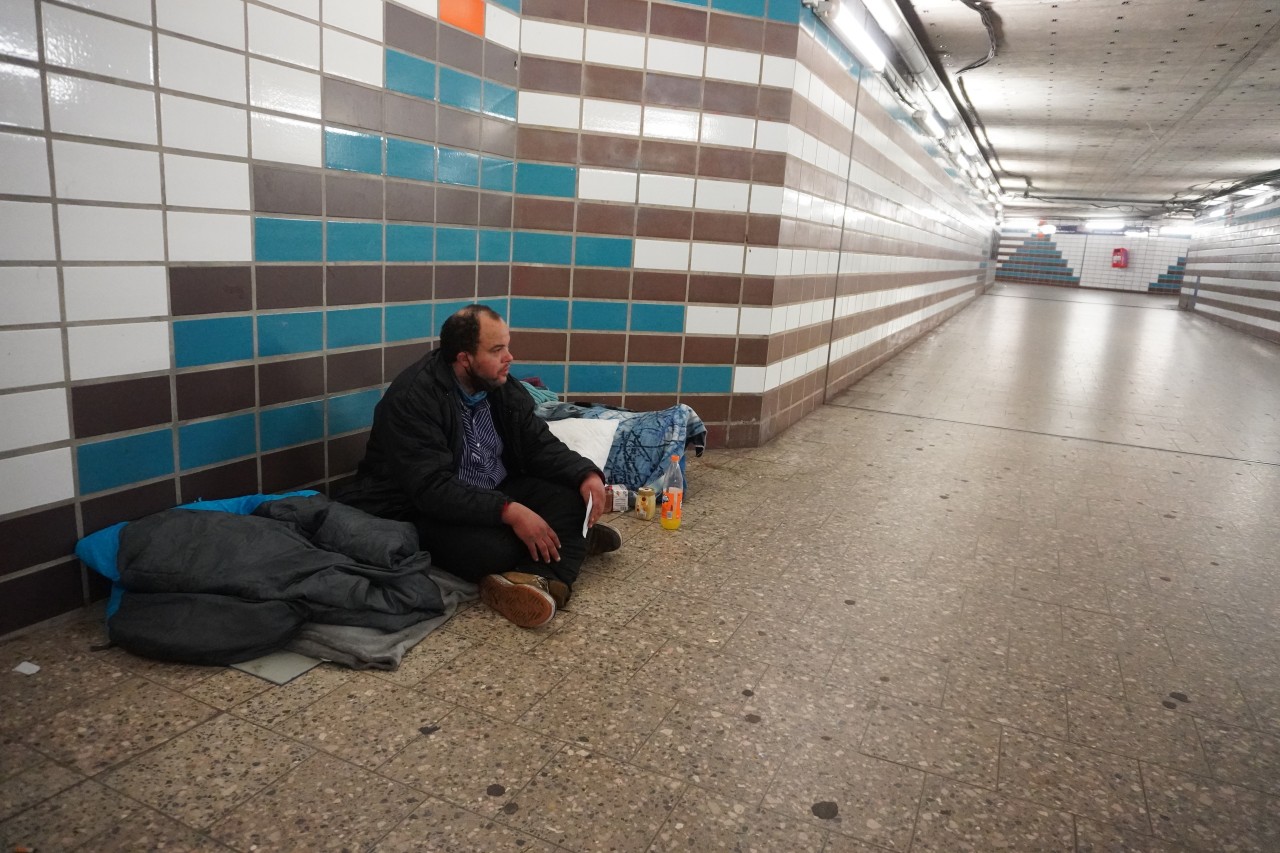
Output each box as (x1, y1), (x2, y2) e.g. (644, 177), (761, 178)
(996, 229), (1190, 292)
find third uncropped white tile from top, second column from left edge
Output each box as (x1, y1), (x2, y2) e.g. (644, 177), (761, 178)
(54, 140), (160, 205)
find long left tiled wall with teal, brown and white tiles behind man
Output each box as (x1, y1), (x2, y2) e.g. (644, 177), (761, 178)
(0, 0), (993, 634)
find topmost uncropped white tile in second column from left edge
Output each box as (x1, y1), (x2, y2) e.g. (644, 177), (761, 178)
(42, 3), (152, 83)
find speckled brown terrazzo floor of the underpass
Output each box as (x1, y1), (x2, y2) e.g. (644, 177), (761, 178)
(0, 288), (1280, 853)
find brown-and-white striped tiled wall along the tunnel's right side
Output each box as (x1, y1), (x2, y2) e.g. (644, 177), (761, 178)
(1179, 196), (1280, 342)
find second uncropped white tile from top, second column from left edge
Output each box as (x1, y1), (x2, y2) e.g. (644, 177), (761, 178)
(49, 74), (156, 145)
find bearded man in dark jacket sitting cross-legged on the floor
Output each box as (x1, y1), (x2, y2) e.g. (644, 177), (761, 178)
(338, 305), (621, 628)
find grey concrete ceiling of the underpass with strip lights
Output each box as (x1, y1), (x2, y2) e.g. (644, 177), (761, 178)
(900, 0), (1280, 219)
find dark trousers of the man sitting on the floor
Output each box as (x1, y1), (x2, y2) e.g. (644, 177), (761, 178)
(417, 476), (586, 585)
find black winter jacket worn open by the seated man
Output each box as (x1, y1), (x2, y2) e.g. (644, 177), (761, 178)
(338, 350), (599, 526)
